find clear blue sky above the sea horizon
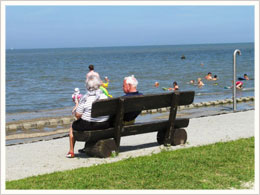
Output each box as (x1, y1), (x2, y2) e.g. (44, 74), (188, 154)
(6, 6), (254, 49)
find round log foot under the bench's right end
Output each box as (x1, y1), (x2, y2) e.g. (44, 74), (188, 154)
(157, 129), (187, 146)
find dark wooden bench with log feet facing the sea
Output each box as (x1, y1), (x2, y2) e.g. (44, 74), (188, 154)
(73, 91), (195, 158)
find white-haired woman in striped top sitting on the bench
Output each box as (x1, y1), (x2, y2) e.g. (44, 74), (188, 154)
(66, 75), (110, 158)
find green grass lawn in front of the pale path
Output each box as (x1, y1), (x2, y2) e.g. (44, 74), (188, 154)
(6, 138), (254, 189)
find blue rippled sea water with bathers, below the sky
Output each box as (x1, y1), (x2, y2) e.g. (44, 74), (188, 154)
(6, 43), (254, 114)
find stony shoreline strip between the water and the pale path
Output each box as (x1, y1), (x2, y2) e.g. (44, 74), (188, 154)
(6, 97), (254, 145)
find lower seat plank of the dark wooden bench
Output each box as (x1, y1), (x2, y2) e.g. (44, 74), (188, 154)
(73, 118), (189, 142)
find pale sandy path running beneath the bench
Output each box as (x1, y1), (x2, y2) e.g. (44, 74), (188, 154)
(5, 110), (255, 181)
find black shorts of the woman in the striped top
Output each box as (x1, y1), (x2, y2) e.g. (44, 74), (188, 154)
(72, 118), (110, 131)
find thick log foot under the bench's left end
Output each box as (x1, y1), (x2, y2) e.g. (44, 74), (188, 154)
(85, 139), (117, 158)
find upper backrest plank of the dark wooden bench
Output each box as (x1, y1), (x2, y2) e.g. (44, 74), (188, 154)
(91, 91), (195, 117)
